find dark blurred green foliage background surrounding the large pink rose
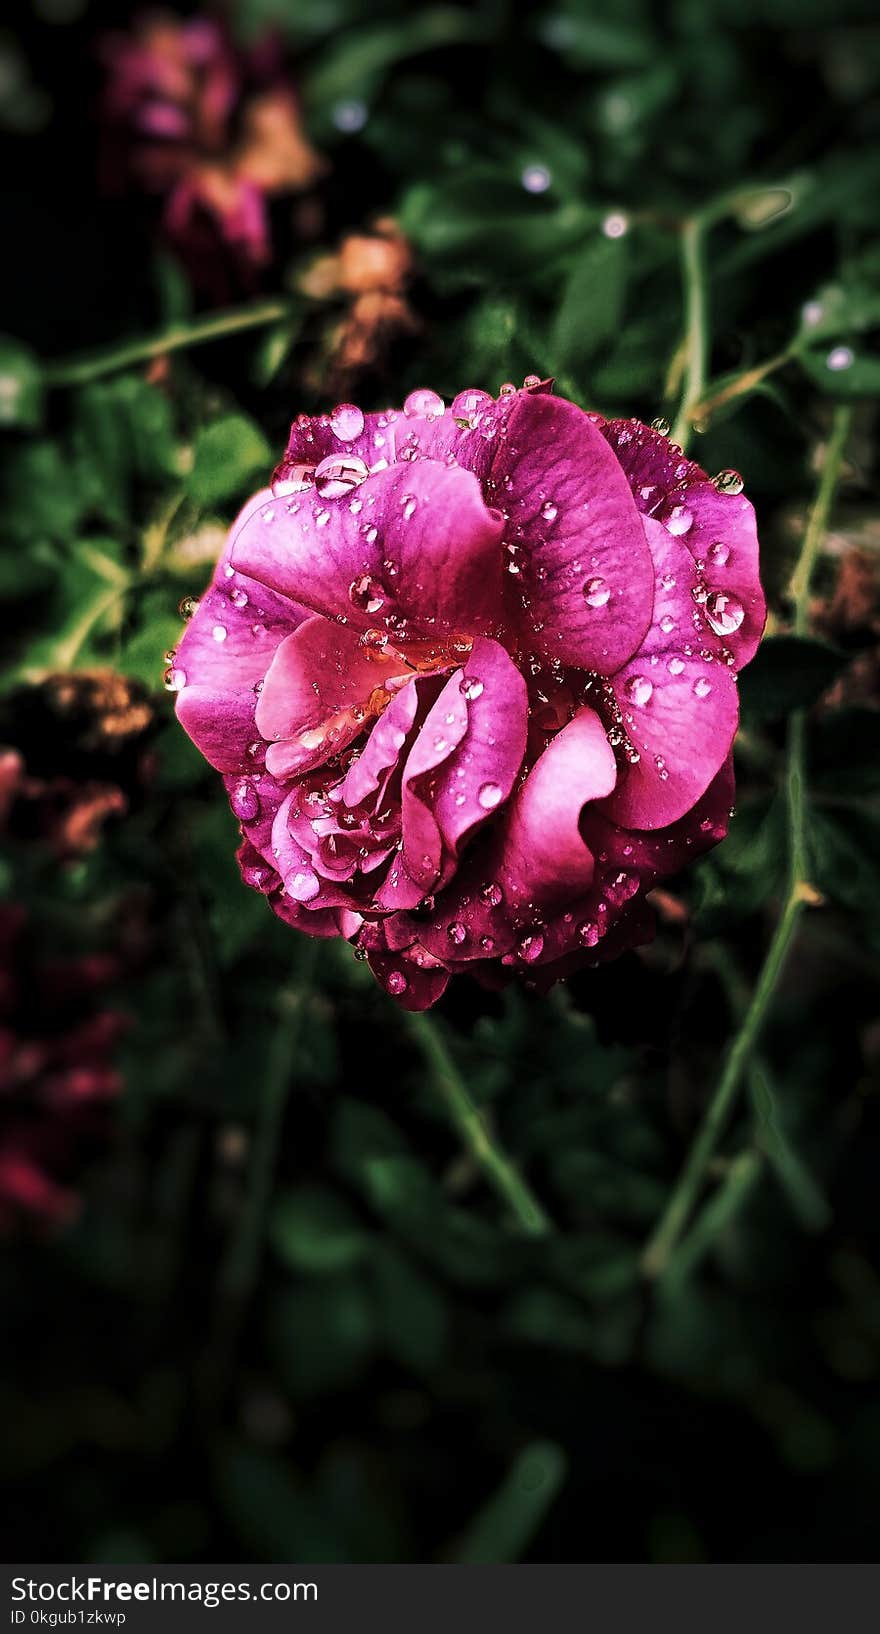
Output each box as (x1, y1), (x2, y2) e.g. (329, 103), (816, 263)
(0, 0), (880, 1562)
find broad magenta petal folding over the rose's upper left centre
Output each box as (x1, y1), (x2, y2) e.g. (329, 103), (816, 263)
(232, 461), (503, 639)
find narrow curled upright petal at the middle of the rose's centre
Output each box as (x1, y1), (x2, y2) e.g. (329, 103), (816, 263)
(403, 637), (529, 892)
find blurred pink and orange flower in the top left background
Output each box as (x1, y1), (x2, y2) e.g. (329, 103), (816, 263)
(101, 13), (325, 301)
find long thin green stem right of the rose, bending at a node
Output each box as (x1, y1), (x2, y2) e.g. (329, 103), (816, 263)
(642, 405), (852, 1278)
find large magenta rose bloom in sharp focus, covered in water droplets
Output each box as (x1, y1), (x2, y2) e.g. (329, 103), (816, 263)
(167, 376), (764, 1010)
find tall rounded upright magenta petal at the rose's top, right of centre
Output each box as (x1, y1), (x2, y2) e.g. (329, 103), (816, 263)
(491, 395), (653, 675)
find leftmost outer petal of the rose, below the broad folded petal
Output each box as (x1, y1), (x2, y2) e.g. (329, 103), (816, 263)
(170, 502), (304, 771)
